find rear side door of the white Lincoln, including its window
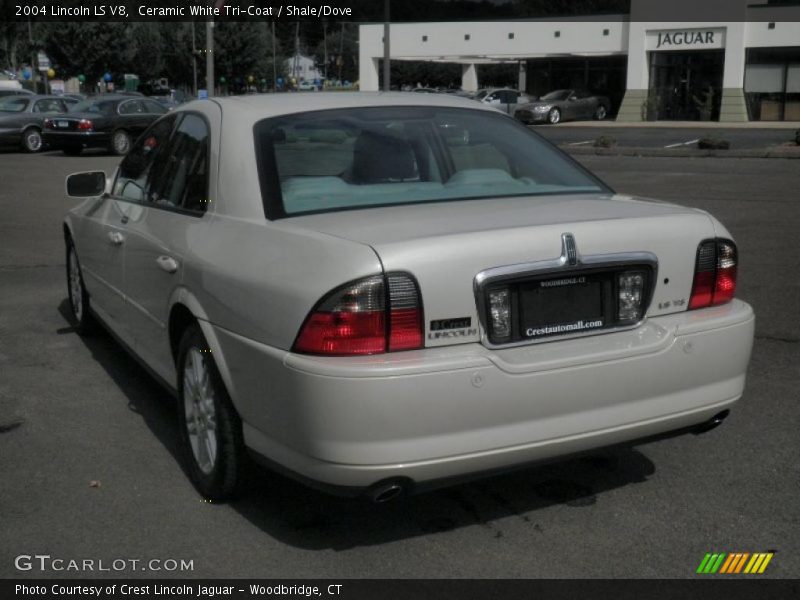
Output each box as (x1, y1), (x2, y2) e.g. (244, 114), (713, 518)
(120, 112), (210, 381)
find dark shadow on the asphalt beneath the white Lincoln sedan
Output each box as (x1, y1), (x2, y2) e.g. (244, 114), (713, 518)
(58, 299), (655, 550)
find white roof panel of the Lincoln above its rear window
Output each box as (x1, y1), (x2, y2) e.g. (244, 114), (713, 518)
(193, 92), (496, 122)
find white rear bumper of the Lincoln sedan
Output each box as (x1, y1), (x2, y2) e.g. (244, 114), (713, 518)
(205, 301), (755, 490)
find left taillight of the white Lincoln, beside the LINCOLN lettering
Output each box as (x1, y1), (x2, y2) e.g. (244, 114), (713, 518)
(294, 273), (423, 356)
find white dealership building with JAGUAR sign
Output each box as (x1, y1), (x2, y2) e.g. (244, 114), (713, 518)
(359, 0), (800, 122)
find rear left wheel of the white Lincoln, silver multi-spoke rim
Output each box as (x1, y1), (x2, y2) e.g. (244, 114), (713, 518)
(178, 324), (245, 502)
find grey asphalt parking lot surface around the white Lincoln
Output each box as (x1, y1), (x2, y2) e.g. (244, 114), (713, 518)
(0, 153), (800, 578)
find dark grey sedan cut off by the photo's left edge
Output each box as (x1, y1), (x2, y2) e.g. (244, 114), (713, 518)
(0, 94), (67, 152)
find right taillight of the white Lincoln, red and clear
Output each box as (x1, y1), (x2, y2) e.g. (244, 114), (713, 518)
(689, 240), (737, 310)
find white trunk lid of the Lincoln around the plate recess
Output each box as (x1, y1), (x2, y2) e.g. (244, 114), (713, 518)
(290, 195), (714, 346)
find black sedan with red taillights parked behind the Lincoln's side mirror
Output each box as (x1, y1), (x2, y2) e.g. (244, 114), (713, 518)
(44, 94), (168, 155)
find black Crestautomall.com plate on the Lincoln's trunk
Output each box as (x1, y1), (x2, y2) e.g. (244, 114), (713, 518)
(519, 275), (606, 339)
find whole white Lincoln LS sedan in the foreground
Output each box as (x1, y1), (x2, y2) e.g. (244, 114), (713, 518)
(63, 93), (754, 501)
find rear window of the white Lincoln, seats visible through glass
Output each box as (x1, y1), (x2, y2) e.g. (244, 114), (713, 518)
(255, 106), (610, 219)
